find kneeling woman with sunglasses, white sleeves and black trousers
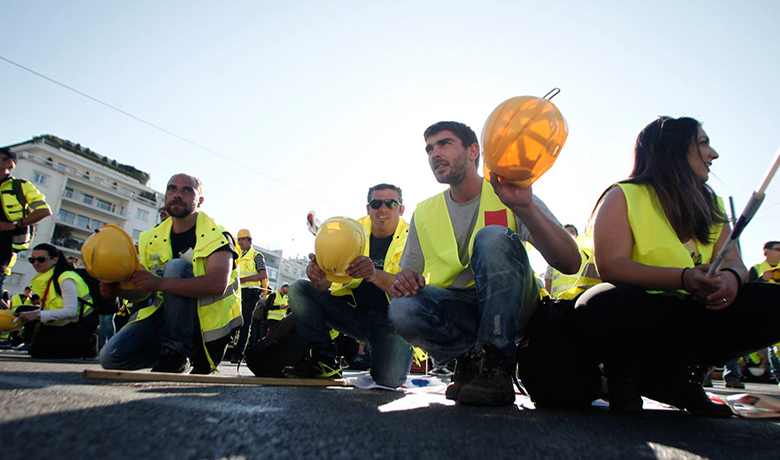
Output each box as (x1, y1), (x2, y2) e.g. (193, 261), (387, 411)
(19, 243), (98, 359)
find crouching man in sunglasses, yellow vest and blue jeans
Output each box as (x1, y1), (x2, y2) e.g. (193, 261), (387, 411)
(283, 184), (412, 388)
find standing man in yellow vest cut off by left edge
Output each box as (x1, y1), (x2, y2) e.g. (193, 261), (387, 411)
(0, 147), (51, 298)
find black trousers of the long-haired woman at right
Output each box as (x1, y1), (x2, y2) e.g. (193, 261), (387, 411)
(575, 283), (780, 367)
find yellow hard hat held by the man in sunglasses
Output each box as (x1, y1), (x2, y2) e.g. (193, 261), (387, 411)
(314, 217), (368, 283)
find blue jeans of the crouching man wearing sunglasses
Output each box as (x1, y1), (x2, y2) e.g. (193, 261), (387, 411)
(289, 280), (412, 388)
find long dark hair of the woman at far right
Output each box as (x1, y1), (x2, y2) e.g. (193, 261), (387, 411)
(622, 117), (728, 244)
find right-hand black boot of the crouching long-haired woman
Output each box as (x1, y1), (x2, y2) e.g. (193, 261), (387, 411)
(640, 364), (734, 418)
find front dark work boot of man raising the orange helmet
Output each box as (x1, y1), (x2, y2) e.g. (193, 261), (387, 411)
(458, 346), (517, 406)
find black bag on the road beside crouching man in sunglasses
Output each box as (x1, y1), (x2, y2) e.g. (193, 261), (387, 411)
(245, 315), (306, 377)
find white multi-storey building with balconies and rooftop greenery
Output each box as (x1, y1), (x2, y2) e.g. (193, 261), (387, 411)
(5, 135), (165, 295)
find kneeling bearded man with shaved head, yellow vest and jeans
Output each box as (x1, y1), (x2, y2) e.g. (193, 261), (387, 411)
(99, 174), (243, 374)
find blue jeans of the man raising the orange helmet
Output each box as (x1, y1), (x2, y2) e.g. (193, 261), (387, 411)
(389, 225), (539, 361)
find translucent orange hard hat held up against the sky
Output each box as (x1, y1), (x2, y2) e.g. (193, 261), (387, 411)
(482, 90), (569, 188)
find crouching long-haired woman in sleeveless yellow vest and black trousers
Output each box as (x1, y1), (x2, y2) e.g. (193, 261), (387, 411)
(575, 117), (780, 417)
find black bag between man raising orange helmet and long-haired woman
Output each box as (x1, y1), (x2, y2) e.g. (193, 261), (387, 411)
(517, 300), (601, 407)
